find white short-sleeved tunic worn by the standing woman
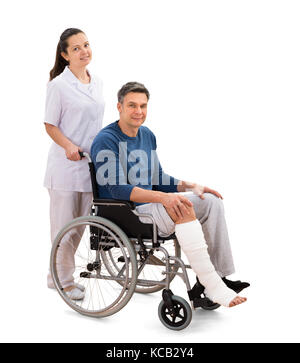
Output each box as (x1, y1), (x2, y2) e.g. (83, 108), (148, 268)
(44, 67), (104, 192)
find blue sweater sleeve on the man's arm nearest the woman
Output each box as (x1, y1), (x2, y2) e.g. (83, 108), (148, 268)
(91, 133), (134, 200)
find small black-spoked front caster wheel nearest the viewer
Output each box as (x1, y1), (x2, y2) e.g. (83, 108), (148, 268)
(158, 295), (192, 330)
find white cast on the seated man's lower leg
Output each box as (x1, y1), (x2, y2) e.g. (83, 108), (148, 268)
(175, 220), (237, 306)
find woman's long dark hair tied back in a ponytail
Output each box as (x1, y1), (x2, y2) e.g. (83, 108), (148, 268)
(50, 28), (83, 81)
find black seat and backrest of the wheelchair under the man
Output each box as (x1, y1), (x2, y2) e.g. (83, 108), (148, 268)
(85, 155), (176, 241)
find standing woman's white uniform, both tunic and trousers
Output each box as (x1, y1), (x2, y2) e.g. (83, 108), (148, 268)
(44, 67), (104, 288)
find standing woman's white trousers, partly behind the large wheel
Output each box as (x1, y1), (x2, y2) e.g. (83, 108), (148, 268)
(47, 189), (93, 288)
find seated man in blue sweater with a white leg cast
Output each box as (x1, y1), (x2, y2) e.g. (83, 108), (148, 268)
(91, 82), (249, 307)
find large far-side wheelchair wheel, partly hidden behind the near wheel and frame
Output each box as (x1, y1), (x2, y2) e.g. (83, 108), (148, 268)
(101, 239), (181, 294)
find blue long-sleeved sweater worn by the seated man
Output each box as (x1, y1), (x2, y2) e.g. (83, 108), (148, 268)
(91, 121), (178, 204)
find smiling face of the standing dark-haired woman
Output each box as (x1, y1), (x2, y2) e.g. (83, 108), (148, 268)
(61, 33), (92, 68)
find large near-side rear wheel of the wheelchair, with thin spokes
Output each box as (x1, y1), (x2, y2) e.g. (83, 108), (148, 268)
(50, 216), (137, 317)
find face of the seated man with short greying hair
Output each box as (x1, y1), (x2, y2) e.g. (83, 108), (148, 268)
(117, 92), (148, 129)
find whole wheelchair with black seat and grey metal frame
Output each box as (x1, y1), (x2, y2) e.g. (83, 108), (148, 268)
(50, 152), (220, 330)
